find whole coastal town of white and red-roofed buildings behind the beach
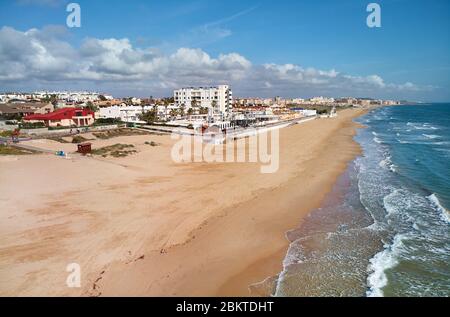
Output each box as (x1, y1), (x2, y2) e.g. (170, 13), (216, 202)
(0, 85), (399, 153)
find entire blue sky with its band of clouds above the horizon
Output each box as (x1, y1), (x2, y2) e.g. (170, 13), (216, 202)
(0, 0), (450, 101)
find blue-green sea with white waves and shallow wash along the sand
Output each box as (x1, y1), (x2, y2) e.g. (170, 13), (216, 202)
(274, 103), (450, 297)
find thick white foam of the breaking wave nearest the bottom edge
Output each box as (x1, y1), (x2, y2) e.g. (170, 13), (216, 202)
(366, 234), (407, 297)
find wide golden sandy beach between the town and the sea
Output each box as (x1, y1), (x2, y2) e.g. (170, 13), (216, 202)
(0, 109), (364, 296)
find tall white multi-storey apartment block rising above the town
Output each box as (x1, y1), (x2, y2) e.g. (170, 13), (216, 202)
(173, 85), (233, 115)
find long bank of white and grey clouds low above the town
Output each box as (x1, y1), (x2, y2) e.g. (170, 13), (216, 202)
(0, 26), (431, 96)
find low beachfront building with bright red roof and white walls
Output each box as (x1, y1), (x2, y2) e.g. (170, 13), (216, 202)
(23, 108), (95, 127)
